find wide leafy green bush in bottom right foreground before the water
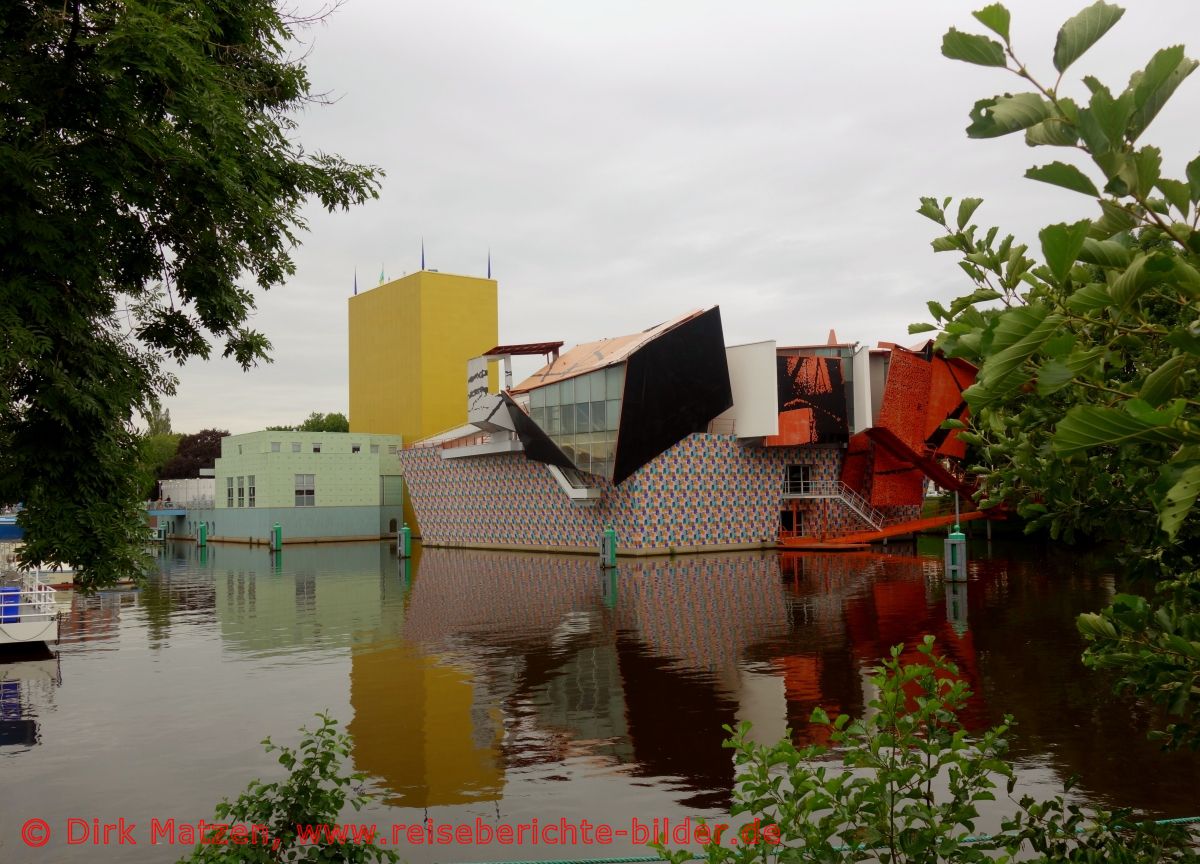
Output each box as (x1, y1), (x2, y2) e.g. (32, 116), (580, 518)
(655, 636), (1196, 864)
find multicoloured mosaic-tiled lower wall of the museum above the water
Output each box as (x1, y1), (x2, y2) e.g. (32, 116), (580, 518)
(401, 433), (902, 552)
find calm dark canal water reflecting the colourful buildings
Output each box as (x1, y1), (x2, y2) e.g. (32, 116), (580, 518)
(0, 544), (1200, 863)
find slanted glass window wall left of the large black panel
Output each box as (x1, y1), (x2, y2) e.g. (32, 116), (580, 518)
(529, 364), (625, 478)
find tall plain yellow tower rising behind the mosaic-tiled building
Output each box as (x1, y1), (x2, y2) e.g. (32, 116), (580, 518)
(349, 270), (499, 524)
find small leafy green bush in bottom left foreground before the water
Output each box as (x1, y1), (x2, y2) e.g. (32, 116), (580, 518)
(181, 714), (400, 864)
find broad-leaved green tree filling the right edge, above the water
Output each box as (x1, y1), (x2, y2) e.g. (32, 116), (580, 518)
(910, 0), (1200, 746)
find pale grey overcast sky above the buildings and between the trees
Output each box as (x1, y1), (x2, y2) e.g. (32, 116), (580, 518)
(167, 0), (1200, 433)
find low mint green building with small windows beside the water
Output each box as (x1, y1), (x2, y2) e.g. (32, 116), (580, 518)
(172, 431), (404, 542)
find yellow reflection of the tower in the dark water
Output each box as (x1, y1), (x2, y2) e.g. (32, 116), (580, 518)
(349, 643), (504, 808)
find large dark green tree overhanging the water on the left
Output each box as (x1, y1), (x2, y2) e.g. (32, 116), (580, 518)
(0, 0), (380, 584)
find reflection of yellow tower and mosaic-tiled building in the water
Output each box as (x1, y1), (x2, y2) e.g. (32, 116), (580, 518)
(350, 550), (788, 806)
